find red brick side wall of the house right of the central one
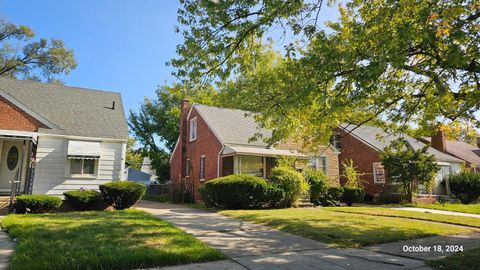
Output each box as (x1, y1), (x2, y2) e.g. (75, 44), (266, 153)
(338, 129), (388, 195)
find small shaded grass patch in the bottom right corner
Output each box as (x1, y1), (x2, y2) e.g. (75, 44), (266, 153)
(427, 248), (480, 270)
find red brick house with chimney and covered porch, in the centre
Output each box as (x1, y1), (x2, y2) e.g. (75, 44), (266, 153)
(170, 100), (339, 200)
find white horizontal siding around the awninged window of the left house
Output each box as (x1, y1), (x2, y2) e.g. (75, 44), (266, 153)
(33, 136), (126, 196)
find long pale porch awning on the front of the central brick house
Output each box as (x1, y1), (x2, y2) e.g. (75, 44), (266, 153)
(223, 145), (306, 157)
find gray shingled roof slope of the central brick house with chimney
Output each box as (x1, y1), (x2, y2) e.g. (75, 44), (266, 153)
(193, 104), (272, 146)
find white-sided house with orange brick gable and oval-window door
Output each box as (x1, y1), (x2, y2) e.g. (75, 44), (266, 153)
(0, 78), (128, 196)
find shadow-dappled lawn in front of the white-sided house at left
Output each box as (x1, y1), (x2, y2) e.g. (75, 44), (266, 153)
(2, 210), (224, 269)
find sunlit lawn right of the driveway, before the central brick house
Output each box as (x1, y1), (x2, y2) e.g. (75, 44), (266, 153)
(219, 208), (473, 247)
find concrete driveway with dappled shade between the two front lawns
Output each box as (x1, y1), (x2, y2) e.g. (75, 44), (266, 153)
(137, 201), (430, 270)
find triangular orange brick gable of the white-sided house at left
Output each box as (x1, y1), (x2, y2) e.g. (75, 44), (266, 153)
(0, 96), (46, 131)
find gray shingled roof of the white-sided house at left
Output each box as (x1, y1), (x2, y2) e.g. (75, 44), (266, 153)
(0, 78), (128, 139)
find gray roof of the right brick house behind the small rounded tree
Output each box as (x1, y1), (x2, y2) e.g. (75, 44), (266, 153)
(342, 125), (463, 163)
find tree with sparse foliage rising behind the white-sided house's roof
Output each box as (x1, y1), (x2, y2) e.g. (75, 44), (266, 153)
(0, 20), (77, 82)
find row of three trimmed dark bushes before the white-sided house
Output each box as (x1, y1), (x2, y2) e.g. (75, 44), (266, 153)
(15, 181), (146, 214)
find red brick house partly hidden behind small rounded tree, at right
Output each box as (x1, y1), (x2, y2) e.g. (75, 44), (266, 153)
(337, 125), (463, 196)
